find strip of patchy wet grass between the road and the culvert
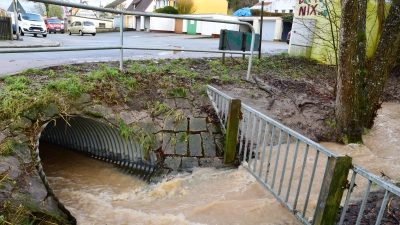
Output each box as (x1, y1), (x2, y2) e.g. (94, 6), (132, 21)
(0, 54), (334, 120)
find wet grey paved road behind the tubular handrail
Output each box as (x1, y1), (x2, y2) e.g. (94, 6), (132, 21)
(0, 31), (288, 76)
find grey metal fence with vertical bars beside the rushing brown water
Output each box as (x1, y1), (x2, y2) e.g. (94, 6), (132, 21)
(207, 86), (400, 224)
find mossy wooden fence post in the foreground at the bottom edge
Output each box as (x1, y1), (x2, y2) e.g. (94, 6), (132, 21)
(312, 156), (352, 225)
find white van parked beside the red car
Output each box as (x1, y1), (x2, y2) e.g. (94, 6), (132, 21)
(18, 13), (47, 37)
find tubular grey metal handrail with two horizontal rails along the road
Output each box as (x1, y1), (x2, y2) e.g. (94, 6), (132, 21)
(0, 0), (255, 79)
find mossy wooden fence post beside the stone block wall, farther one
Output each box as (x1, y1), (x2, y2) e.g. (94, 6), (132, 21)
(224, 99), (242, 164)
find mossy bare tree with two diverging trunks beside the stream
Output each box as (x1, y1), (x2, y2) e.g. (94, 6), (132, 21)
(335, 0), (400, 143)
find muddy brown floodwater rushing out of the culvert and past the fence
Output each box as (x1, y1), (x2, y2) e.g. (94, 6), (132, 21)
(40, 103), (400, 224)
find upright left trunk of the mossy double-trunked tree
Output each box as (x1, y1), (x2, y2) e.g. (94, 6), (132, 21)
(335, 0), (367, 143)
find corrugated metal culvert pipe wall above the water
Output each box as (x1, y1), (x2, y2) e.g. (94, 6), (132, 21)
(40, 116), (157, 179)
